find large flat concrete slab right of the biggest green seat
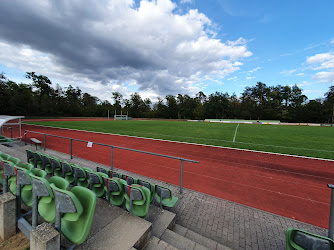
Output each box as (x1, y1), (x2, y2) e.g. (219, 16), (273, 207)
(76, 199), (152, 250)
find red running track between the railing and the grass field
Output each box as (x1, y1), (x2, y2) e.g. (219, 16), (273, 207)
(23, 125), (334, 228)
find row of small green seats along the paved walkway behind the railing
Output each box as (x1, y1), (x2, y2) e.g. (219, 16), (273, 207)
(27, 150), (178, 217)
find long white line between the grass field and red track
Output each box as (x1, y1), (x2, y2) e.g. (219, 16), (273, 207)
(24, 123), (334, 162)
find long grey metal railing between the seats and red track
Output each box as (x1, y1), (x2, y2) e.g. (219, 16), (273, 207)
(24, 130), (199, 194)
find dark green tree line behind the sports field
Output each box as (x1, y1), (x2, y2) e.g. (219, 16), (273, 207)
(0, 72), (334, 123)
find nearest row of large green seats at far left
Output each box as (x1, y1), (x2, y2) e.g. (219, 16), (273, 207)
(1, 152), (96, 244)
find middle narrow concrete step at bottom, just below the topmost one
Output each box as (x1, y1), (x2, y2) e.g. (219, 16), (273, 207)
(161, 229), (208, 250)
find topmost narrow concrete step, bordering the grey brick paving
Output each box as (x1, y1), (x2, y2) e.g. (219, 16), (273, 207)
(173, 224), (230, 250)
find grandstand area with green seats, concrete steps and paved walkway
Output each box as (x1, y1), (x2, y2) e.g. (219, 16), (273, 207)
(0, 131), (331, 249)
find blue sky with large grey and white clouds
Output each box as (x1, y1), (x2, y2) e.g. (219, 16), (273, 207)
(0, 0), (334, 102)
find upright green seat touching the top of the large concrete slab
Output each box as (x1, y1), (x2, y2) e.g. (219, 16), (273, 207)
(124, 184), (151, 218)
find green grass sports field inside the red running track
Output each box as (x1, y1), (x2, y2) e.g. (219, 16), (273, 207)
(27, 120), (334, 159)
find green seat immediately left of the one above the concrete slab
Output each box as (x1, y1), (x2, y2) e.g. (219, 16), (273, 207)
(103, 177), (127, 206)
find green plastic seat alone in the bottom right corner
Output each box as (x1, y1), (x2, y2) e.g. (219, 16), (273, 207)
(285, 228), (334, 250)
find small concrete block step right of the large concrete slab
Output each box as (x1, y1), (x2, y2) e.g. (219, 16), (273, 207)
(145, 204), (176, 238)
